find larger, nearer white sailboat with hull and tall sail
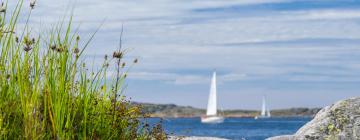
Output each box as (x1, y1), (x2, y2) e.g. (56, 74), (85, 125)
(201, 72), (224, 123)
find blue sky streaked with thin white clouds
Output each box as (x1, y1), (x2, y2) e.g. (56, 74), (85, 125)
(7, 0), (360, 109)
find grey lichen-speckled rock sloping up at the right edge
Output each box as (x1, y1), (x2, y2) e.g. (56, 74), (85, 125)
(268, 98), (360, 140)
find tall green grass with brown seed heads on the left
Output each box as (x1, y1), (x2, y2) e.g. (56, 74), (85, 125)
(0, 1), (166, 139)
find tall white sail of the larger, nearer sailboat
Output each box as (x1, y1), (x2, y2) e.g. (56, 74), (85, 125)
(206, 72), (217, 116)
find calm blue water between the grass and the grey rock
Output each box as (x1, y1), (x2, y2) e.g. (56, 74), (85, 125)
(150, 118), (311, 140)
